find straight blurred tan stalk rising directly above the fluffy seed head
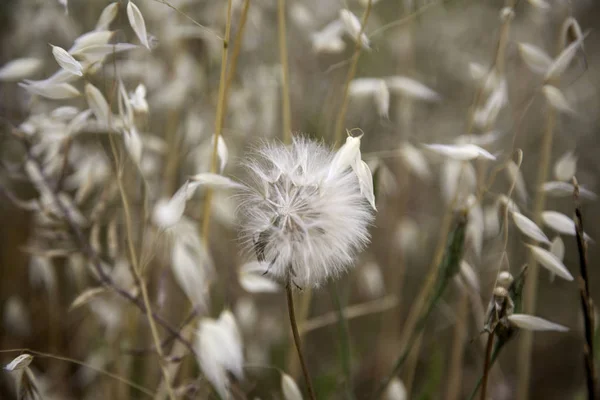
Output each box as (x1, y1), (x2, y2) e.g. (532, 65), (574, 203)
(277, 0), (292, 143)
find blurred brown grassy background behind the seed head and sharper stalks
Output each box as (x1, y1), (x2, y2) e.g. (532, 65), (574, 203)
(0, 0), (600, 400)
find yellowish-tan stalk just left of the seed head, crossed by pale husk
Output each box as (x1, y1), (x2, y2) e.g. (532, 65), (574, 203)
(202, 0), (233, 239)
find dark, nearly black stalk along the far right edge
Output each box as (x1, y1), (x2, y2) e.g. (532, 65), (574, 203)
(573, 178), (598, 400)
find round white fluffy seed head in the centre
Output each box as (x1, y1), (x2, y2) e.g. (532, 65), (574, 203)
(240, 137), (373, 287)
